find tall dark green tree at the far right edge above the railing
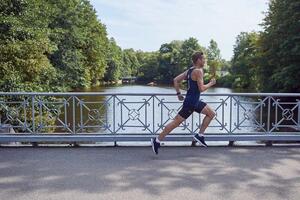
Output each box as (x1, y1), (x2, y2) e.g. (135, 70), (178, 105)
(257, 0), (300, 92)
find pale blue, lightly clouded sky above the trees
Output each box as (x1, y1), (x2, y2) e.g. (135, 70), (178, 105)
(91, 0), (268, 60)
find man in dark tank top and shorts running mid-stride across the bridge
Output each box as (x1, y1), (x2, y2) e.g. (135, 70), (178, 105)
(151, 52), (216, 154)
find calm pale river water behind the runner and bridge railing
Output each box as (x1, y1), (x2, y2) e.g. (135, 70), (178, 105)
(69, 85), (255, 134)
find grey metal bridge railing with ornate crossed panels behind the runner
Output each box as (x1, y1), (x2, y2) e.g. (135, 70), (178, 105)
(0, 91), (300, 142)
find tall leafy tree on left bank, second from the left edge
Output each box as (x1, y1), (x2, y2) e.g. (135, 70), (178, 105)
(49, 0), (108, 88)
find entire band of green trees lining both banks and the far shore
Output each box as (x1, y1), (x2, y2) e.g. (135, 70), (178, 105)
(0, 0), (300, 92)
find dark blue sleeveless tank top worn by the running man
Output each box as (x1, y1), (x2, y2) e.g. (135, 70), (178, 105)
(183, 67), (200, 107)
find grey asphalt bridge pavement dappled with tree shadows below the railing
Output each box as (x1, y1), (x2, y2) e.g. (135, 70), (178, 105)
(0, 146), (300, 200)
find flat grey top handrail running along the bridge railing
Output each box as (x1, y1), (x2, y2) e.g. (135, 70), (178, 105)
(0, 92), (300, 97)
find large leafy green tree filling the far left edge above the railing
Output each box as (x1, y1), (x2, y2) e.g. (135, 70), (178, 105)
(0, 0), (58, 91)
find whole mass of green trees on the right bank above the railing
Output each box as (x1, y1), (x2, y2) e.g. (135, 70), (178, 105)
(231, 0), (300, 92)
